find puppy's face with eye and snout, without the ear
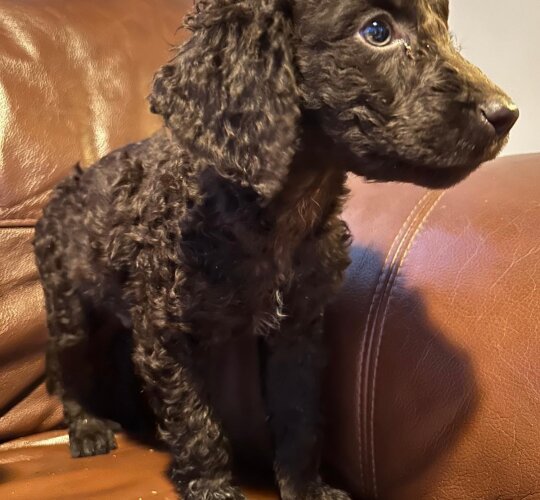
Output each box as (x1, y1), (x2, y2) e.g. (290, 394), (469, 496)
(295, 0), (518, 186)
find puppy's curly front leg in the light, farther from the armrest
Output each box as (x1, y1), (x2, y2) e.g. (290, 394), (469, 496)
(134, 318), (245, 500)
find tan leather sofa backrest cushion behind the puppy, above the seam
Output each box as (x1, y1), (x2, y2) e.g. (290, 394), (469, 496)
(0, 0), (192, 221)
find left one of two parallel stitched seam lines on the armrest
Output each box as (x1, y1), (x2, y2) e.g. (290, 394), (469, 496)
(355, 192), (430, 492)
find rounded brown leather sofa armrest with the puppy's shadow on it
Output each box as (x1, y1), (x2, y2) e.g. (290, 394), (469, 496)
(326, 155), (540, 500)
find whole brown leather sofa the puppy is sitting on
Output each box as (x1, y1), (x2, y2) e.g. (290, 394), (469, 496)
(0, 0), (540, 500)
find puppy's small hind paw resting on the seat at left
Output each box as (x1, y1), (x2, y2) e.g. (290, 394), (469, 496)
(69, 417), (117, 458)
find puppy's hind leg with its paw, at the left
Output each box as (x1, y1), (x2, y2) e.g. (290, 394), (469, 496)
(44, 288), (116, 458)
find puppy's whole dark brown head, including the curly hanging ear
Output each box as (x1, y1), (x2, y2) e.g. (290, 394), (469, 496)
(151, 0), (518, 198)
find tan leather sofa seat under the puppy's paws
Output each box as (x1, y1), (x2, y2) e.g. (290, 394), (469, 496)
(0, 432), (278, 500)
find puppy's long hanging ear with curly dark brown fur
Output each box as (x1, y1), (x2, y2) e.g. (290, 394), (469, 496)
(150, 0), (300, 199)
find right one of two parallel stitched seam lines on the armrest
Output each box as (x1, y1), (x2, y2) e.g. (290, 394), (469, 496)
(369, 191), (446, 498)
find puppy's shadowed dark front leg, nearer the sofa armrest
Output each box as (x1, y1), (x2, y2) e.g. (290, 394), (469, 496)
(265, 312), (349, 500)
